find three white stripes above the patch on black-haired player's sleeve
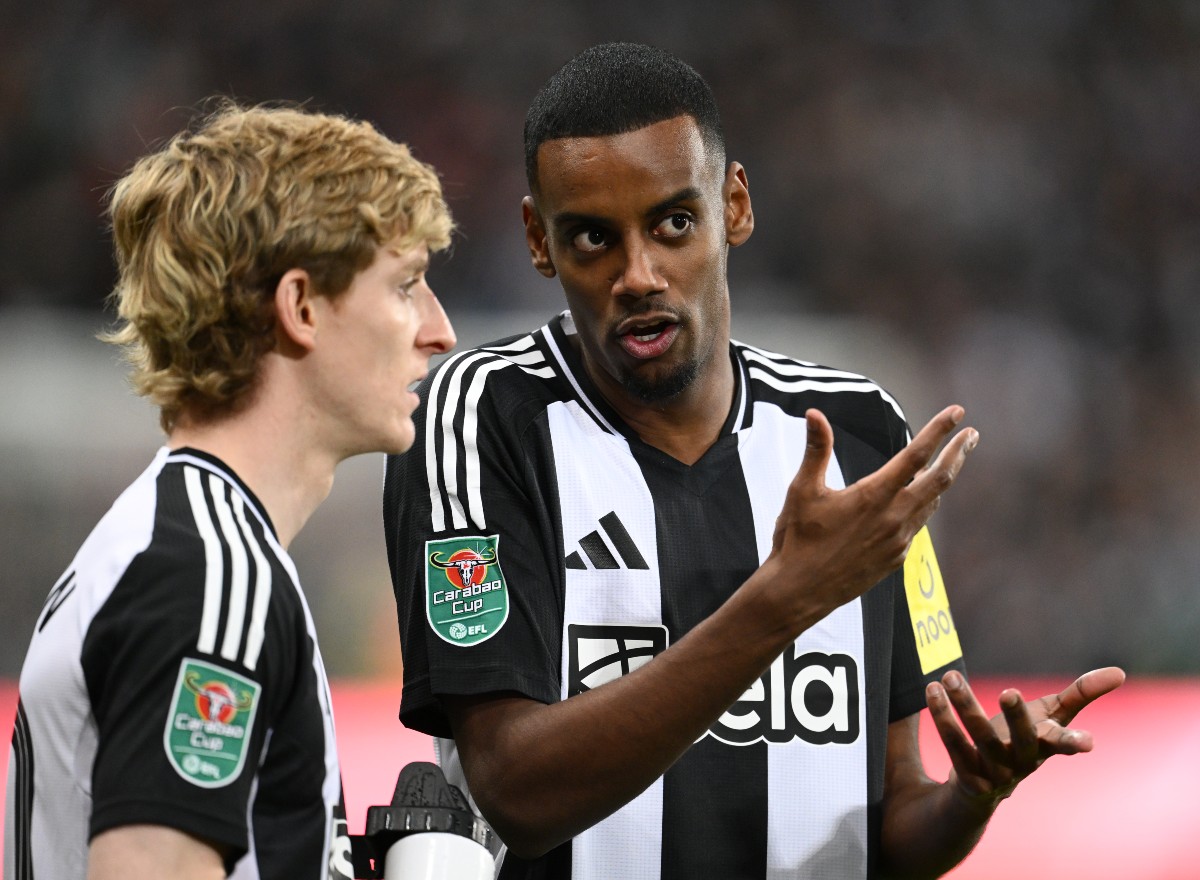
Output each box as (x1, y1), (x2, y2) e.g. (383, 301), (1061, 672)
(425, 335), (554, 532)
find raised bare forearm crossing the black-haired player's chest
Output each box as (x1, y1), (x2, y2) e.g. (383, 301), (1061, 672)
(448, 573), (796, 856)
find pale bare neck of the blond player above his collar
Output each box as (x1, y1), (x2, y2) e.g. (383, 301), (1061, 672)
(167, 393), (338, 547)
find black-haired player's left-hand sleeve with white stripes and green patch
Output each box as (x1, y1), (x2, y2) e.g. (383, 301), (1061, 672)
(384, 359), (562, 737)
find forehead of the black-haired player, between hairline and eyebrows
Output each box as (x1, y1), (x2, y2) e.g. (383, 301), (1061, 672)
(538, 116), (722, 221)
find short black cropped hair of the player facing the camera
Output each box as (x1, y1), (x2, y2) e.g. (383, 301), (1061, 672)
(524, 43), (725, 191)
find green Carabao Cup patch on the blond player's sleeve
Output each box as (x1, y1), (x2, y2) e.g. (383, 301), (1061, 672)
(162, 658), (260, 789)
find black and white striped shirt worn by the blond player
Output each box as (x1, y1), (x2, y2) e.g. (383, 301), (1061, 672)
(4, 449), (353, 880)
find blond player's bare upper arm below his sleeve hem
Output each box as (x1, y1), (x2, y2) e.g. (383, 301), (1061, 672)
(88, 825), (226, 880)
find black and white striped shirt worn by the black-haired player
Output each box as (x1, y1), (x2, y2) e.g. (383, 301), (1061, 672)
(384, 313), (961, 880)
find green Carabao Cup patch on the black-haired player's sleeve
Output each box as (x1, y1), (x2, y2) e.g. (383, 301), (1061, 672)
(425, 534), (509, 647)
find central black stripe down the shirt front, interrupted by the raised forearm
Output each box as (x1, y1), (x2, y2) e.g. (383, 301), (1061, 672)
(635, 435), (768, 880)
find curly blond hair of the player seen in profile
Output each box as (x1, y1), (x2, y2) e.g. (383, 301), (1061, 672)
(101, 101), (454, 433)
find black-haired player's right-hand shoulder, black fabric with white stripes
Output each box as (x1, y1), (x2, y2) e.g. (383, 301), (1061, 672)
(733, 342), (910, 457)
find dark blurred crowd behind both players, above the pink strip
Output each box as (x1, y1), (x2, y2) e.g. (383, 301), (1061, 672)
(0, 0), (1200, 677)
